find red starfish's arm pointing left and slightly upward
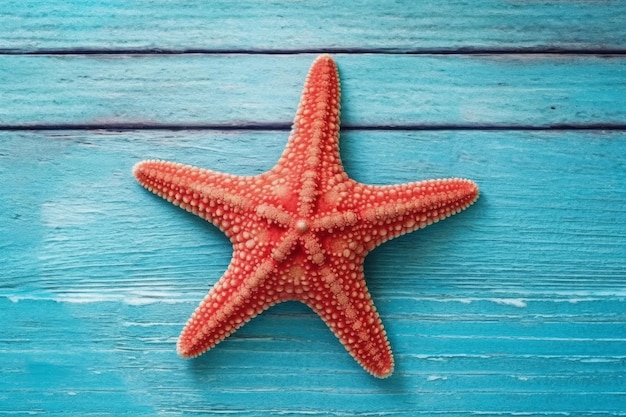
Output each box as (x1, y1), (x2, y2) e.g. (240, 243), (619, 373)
(133, 160), (258, 239)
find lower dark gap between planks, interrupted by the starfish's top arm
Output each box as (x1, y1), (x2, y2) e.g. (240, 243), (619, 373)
(0, 123), (626, 131)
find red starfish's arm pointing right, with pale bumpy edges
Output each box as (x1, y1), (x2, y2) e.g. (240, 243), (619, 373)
(350, 178), (478, 252)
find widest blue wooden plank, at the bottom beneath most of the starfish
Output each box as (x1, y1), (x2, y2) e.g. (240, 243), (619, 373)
(0, 130), (626, 416)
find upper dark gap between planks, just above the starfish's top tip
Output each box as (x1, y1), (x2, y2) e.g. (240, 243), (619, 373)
(0, 46), (626, 56)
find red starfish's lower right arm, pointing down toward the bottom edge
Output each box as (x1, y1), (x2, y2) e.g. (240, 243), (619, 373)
(307, 260), (394, 378)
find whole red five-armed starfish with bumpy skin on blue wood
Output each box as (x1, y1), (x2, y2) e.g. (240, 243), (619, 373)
(134, 55), (478, 378)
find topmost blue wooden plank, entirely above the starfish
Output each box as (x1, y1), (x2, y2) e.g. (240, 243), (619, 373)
(0, 0), (626, 52)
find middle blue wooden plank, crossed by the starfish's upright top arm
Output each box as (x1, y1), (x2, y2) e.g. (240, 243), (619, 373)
(0, 55), (626, 127)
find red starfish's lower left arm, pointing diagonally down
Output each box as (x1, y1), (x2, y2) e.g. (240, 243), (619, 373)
(177, 257), (278, 358)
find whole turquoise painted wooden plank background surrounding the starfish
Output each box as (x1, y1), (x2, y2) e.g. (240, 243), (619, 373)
(0, 0), (626, 417)
